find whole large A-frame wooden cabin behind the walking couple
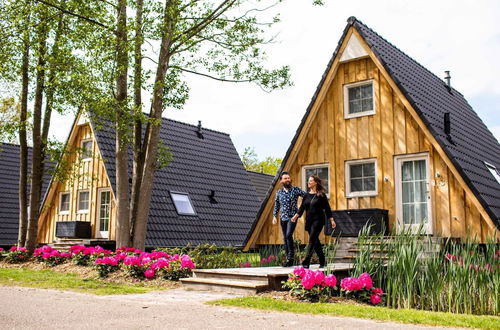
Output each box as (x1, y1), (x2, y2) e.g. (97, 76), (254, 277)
(245, 17), (500, 249)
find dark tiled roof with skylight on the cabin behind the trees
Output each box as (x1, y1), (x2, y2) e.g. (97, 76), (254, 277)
(93, 114), (260, 247)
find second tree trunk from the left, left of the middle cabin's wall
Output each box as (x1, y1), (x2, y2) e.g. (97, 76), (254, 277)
(26, 12), (48, 253)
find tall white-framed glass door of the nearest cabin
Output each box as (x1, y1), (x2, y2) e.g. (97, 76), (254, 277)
(395, 154), (432, 234)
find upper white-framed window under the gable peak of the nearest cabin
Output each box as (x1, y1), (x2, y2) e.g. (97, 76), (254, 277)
(344, 80), (375, 119)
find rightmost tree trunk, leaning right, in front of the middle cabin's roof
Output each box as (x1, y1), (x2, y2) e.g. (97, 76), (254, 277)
(133, 0), (175, 249)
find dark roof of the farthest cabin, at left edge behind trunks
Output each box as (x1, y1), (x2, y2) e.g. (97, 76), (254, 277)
(0, 143), (53, 245)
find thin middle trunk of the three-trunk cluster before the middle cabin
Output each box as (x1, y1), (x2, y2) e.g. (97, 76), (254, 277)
(130, 0), (144, 242)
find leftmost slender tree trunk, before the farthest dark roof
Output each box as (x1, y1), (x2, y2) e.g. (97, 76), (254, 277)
(17, 19), (30, 247)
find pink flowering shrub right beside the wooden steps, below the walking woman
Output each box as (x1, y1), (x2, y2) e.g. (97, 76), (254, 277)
(283, 266), (337, 301)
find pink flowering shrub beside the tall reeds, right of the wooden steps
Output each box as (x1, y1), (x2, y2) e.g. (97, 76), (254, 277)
(340, 273), (384, 305)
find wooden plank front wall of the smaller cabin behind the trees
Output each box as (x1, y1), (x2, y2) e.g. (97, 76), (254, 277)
(39, 124), (116, 243)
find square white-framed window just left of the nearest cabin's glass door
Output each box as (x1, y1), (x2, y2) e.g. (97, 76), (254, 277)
(346, 159), (377, 197)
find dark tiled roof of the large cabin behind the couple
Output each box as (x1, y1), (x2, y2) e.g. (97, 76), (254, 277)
(247, 17), (500, 245)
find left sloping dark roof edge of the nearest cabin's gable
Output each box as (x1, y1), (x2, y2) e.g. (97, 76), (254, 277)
(244, 16), (357, 246)
